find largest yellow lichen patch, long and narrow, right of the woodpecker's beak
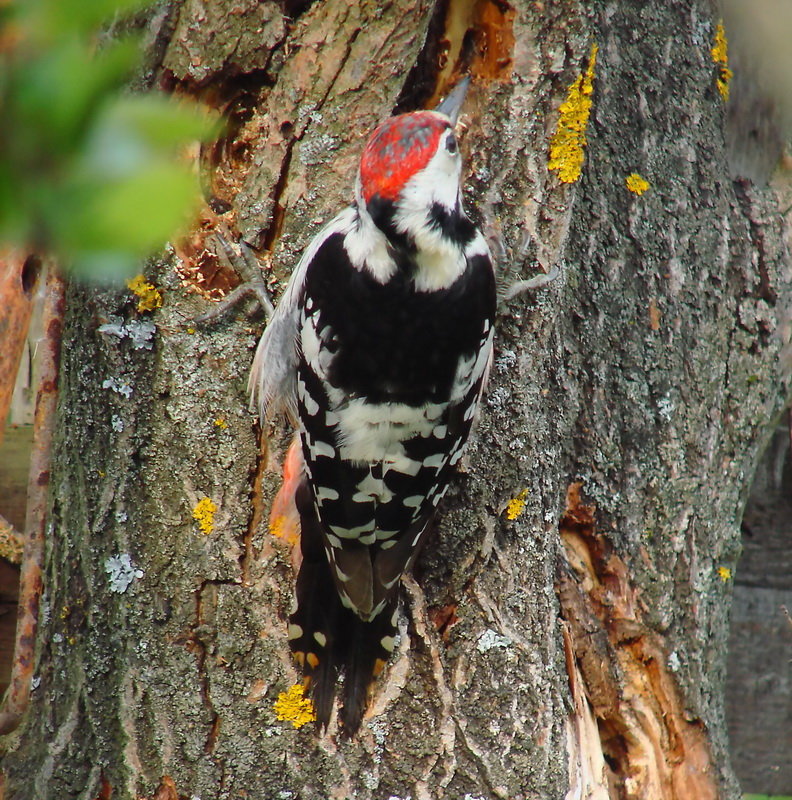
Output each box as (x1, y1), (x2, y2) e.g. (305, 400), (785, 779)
(547, 44), (598, 183)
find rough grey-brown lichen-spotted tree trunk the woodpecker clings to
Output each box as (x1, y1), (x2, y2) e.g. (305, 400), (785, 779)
(4, 0), (792, 800)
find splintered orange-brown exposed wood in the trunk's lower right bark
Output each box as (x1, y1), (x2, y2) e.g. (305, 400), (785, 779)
(559, 484), (720, 800)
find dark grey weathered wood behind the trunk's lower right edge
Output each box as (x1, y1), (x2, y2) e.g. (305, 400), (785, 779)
(726, 418), (792, 795)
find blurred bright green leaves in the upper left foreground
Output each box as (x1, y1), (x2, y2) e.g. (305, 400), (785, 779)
(0, 0), (219, 279)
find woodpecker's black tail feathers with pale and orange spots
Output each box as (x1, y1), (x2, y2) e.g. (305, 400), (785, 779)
(289, 484), (398, 736)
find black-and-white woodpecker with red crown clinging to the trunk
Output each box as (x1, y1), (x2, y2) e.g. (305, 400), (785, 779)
(250, 79), (496, 735)
